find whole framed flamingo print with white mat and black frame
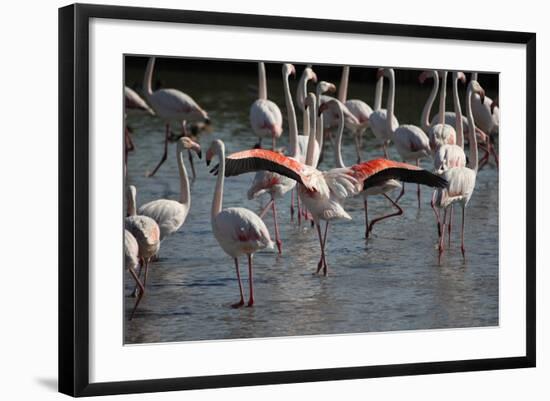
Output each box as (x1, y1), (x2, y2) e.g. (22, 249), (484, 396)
(59, 4), (536, 396)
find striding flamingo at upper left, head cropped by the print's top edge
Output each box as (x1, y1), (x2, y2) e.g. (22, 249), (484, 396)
(143, 57), (210, 179)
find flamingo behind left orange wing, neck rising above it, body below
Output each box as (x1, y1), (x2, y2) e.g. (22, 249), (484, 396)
(247, 64), (300, 254)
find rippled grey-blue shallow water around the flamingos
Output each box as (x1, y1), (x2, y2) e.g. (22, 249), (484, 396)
(124, 61), (499, 343)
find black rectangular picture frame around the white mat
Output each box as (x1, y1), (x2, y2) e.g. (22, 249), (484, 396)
(59, 4), (536, 396)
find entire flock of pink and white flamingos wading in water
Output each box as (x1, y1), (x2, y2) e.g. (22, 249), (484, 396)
(124, 58), (500, 319)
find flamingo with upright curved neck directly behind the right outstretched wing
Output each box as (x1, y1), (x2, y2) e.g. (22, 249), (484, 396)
(381, 68), (431, 208)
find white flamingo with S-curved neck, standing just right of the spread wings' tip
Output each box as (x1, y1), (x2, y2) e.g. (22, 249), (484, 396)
(432, 80), (485, 256)
